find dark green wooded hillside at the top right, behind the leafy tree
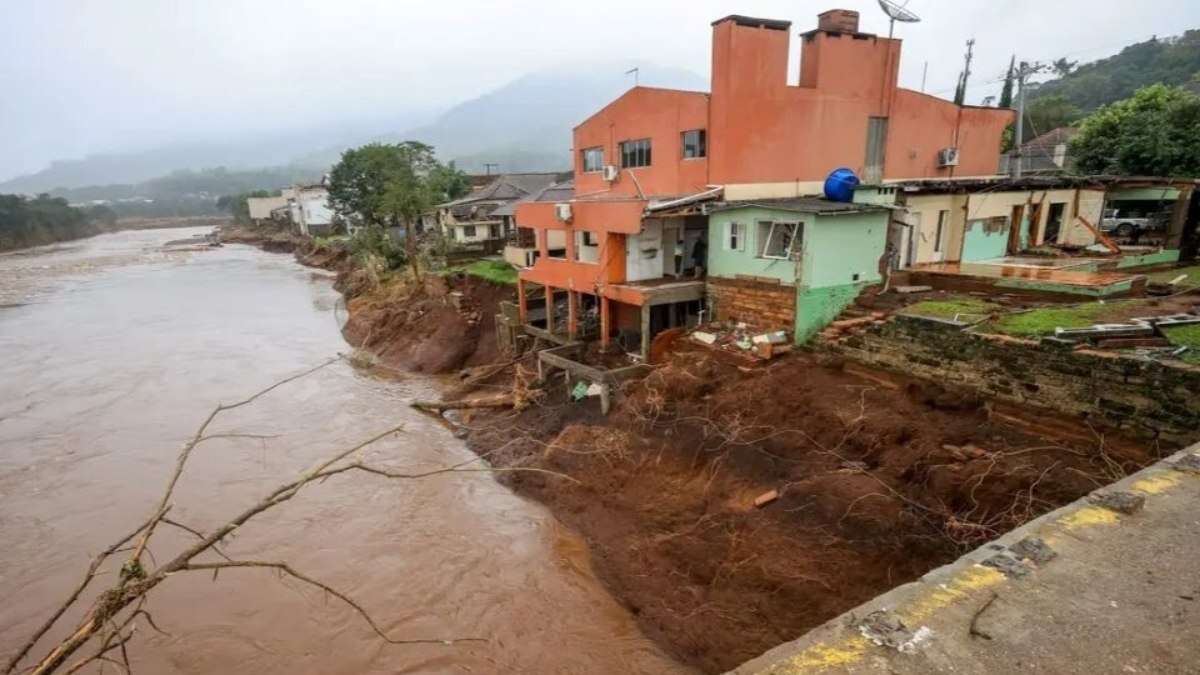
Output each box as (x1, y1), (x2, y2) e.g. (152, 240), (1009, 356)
(1030, 30), (1200, 112)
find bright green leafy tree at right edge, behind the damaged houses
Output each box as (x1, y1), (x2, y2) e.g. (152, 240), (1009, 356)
(1070, 84), (1200, 178)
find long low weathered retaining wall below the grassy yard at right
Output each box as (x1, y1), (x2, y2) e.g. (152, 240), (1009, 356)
(826, 316), (1200, 444)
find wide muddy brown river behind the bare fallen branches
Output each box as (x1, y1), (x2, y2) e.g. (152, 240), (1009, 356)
(0, 229), (685, 674)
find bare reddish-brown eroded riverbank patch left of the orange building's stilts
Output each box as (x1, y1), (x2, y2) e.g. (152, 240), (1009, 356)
(348, 273), (515, 372)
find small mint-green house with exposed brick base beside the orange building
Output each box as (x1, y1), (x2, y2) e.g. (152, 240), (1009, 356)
(706, 197), (889, 344)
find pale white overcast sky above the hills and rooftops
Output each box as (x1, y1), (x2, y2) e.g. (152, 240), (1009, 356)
(7, 0), (1200, 179)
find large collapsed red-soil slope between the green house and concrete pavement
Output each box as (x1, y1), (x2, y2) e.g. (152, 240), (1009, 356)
(469, 351), (1157, 673)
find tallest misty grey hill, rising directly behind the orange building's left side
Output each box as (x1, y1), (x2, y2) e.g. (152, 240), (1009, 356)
(295, 62), (708, 173)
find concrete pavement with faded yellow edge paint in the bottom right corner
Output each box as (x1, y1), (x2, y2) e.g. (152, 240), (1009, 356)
(734, 444), (1200, 675)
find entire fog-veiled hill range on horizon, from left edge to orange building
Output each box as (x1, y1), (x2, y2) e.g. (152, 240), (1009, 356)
(0, 62), (708, 193)
